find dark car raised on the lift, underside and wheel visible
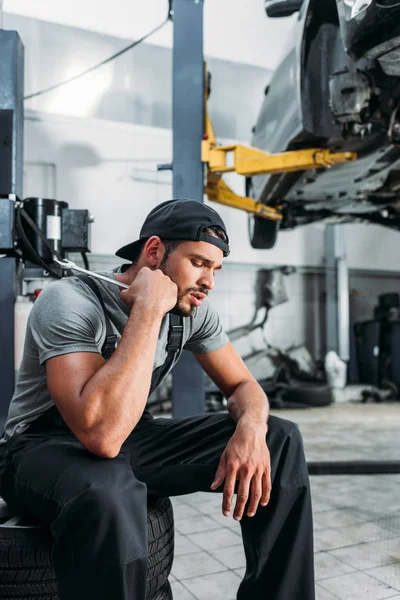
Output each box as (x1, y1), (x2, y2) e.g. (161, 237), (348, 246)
(250, 0), (400, 248)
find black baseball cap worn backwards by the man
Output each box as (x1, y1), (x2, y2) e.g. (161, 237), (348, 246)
(115, 199), (229, 261)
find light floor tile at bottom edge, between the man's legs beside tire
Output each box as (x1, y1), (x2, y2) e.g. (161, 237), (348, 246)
(180, 571), (241, 600)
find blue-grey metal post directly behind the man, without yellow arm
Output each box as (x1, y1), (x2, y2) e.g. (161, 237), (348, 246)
(172, 0), (205, 417)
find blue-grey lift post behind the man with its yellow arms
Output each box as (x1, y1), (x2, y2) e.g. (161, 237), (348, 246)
(172, 0), (357, 416)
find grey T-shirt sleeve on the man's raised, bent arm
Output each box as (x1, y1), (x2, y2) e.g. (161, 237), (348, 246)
(28, 280), (103, 365)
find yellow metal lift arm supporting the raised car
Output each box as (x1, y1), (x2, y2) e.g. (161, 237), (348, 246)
(201, 94), (357, 221)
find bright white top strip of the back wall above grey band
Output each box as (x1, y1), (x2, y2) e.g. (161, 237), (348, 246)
(4, 0), (296, 69)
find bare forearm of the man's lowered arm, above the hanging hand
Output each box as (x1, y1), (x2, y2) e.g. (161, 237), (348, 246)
(228, 381), (269, 426)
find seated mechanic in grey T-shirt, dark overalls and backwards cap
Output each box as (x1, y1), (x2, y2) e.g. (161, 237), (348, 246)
(0, 200), (314, 600)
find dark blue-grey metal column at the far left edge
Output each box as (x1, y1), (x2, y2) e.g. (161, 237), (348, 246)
(0, 30), (24, 425)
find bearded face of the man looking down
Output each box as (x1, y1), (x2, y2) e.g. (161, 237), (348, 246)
(160, 242), (223, 317)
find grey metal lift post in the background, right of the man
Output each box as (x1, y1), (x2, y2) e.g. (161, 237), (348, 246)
(325, 225), (350, 361)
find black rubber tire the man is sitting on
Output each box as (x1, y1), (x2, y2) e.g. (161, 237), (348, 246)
(0, 497), (174, 600)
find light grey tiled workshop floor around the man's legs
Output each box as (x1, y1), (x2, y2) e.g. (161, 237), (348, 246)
(166, 403), (400, 600)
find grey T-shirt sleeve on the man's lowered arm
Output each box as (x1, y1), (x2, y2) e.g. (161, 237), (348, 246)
(184, 299), (229, 354)
